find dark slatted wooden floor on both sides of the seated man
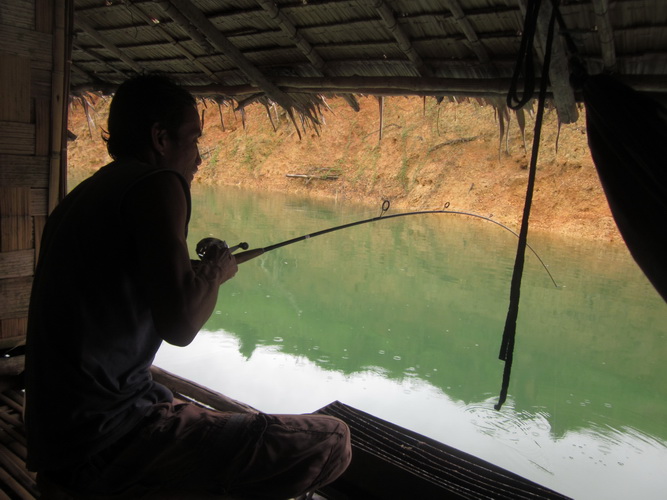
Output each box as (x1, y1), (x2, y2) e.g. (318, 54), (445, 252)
(0, 368), (567, 500)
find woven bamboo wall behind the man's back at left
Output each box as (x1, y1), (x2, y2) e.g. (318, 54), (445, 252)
(0, 0), (72, 349)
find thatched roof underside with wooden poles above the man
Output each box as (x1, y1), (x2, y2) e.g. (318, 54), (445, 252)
(71, 0), (667, 122)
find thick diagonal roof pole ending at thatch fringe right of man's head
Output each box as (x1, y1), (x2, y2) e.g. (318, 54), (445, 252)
(159, 0), (310, 116)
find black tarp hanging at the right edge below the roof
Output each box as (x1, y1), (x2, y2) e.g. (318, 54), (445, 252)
(583, 75), (667, 301)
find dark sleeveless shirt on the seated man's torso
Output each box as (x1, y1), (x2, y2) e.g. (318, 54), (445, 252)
(25, 161), (191, 471)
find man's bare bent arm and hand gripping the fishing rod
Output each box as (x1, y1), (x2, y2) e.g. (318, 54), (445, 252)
(123, 174), (238, 346)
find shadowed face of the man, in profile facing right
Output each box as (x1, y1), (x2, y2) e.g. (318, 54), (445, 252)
(162, 106), (202, 185)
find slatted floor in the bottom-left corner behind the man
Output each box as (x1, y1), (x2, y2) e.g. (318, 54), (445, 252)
(0, 389), (39, 500)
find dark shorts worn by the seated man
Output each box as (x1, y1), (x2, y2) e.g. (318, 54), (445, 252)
(44, 403), (351, 499)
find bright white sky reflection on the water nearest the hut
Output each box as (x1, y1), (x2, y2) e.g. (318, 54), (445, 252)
(157, 331), (667, 499)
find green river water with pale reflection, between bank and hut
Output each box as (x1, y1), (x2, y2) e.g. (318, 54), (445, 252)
(156, 187), (667, 500)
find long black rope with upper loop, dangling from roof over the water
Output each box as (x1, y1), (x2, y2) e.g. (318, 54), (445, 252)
(494, 0), (556, 410)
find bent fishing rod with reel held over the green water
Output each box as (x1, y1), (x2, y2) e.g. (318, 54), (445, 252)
(196, 200), (558, 288)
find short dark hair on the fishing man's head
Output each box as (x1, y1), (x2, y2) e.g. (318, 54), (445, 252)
(105, 75), (196, 160)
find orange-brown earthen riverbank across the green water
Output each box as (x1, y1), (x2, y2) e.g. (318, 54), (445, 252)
(68, 97), (622, 243)
